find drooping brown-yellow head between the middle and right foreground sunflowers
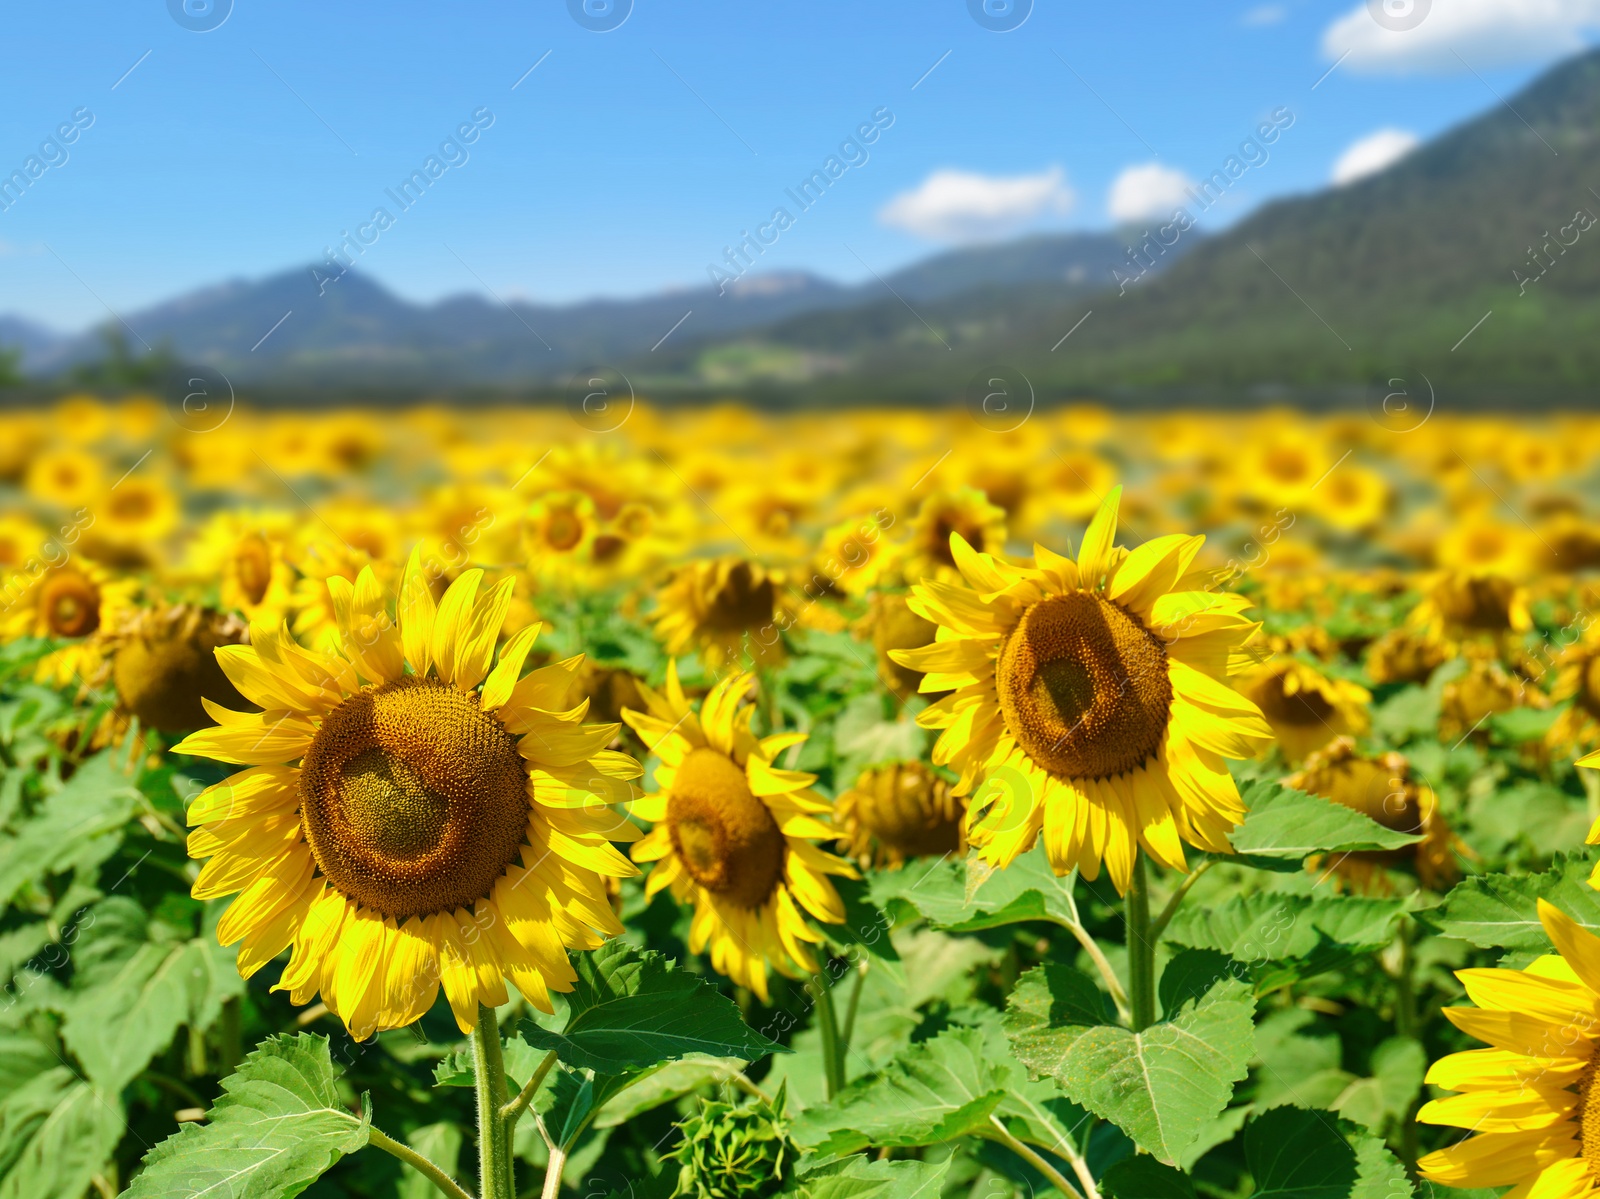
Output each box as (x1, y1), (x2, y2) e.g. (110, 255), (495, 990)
(835, 762), (966, 866)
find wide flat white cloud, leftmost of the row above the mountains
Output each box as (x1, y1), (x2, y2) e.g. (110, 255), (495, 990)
(878, 166), (1077, 242)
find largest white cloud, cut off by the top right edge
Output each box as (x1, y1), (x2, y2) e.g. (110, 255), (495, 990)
(1322, 0), (1600, 75)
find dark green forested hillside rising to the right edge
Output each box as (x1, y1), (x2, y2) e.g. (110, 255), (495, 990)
(643, 51), (1600, 402)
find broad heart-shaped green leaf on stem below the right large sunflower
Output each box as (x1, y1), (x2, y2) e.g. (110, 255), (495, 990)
(1006, 967), (1254, 1165)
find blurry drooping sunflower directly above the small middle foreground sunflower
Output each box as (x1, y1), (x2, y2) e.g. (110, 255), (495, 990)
(650, 555), (794, 671)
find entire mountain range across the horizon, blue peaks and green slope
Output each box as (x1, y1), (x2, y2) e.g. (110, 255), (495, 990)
(9, 51), (1600, 405)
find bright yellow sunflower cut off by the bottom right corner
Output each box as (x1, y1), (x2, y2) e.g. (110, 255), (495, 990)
(1416, 900), (1600, 1199)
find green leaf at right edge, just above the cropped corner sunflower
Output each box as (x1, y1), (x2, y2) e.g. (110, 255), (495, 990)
(1418, 855), (1600, 952)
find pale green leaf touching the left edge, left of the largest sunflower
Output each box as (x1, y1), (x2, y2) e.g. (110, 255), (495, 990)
(0, 749), (139, 906)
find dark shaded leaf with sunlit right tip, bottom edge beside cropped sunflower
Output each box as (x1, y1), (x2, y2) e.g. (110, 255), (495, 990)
(1245, 1108), (1416, 1199)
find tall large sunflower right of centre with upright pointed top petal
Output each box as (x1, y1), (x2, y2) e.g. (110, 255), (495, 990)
(890, 488), (1272, 890)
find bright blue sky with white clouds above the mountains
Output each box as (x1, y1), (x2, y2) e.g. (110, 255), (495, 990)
(0, 0), (1594, 328)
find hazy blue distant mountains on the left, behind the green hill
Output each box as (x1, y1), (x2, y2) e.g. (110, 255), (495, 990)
(21, 234), (1152, 389)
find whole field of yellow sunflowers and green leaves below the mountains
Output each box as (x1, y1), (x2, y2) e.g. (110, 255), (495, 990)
(0, 395), (1600, 1199)
